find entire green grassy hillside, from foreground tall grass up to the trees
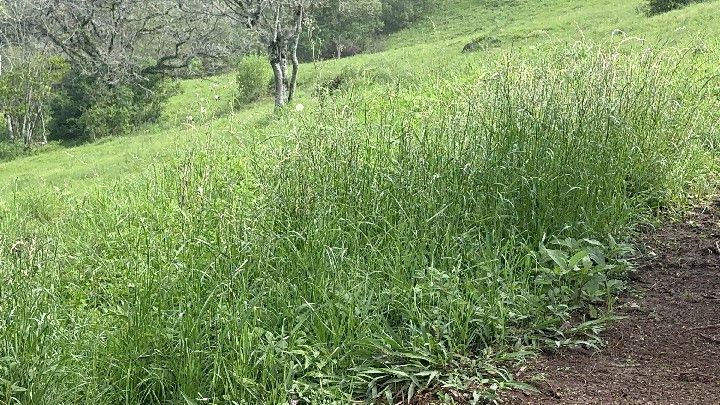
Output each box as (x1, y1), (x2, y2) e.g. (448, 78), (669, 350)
(0, 0), (720, 404)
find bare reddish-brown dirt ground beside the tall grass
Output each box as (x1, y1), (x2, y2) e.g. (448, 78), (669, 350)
(504, 203), (720, 405)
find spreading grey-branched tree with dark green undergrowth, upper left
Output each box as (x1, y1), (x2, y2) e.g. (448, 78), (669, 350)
(26, 0), (221, 139)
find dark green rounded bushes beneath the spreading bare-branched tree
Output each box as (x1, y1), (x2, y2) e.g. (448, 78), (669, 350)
(50, 72), (177, 141)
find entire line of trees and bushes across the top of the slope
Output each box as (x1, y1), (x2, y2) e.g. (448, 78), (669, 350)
(0, 0), (435, 147)
